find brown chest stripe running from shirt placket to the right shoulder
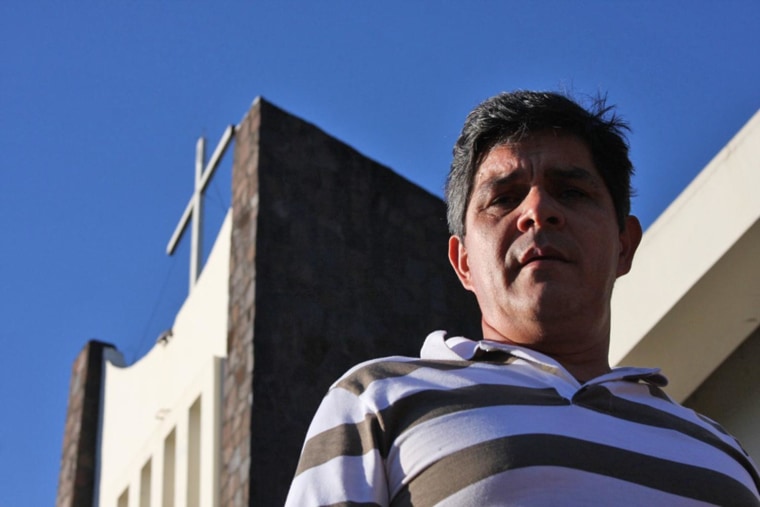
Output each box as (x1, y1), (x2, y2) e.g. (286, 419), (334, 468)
(573, 385), (760, 490)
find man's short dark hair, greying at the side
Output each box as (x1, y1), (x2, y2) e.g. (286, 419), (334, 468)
(446, 91), (633, 237)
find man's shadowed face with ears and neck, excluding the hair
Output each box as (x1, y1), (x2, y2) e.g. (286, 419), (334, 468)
(449, 131), (641, 348)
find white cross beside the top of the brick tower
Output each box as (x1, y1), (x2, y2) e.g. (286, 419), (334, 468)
(166, 125), (235, 291)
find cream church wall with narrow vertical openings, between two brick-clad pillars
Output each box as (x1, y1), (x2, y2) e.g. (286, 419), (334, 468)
(98, 214), (231, 507)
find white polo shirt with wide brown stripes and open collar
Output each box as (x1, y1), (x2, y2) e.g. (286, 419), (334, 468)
(286, 331), (760, 507)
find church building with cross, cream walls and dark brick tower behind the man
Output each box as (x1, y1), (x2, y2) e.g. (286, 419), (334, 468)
(56, 98), (760, 507)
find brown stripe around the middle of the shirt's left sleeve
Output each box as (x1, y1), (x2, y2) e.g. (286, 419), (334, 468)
(296, 415), (380, 476)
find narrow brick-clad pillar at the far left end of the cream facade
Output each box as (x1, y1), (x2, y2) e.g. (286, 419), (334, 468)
(55, 340), (115, 507)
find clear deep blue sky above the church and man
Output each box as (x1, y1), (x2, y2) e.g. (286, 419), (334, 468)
(0, 0), (760, 507)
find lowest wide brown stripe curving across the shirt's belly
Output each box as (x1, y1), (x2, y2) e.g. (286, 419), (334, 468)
(391, 434), (760, 507)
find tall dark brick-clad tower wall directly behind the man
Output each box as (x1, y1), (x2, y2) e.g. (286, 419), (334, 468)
(220, 100), (480, 506)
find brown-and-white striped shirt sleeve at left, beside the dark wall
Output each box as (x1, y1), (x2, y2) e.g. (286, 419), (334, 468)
(285, 387), (388, 507)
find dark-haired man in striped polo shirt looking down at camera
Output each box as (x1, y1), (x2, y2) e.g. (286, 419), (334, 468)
(288, 92), (760, 506)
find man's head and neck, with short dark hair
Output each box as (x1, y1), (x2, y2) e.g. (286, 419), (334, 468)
(447, 92), (641, 374)
